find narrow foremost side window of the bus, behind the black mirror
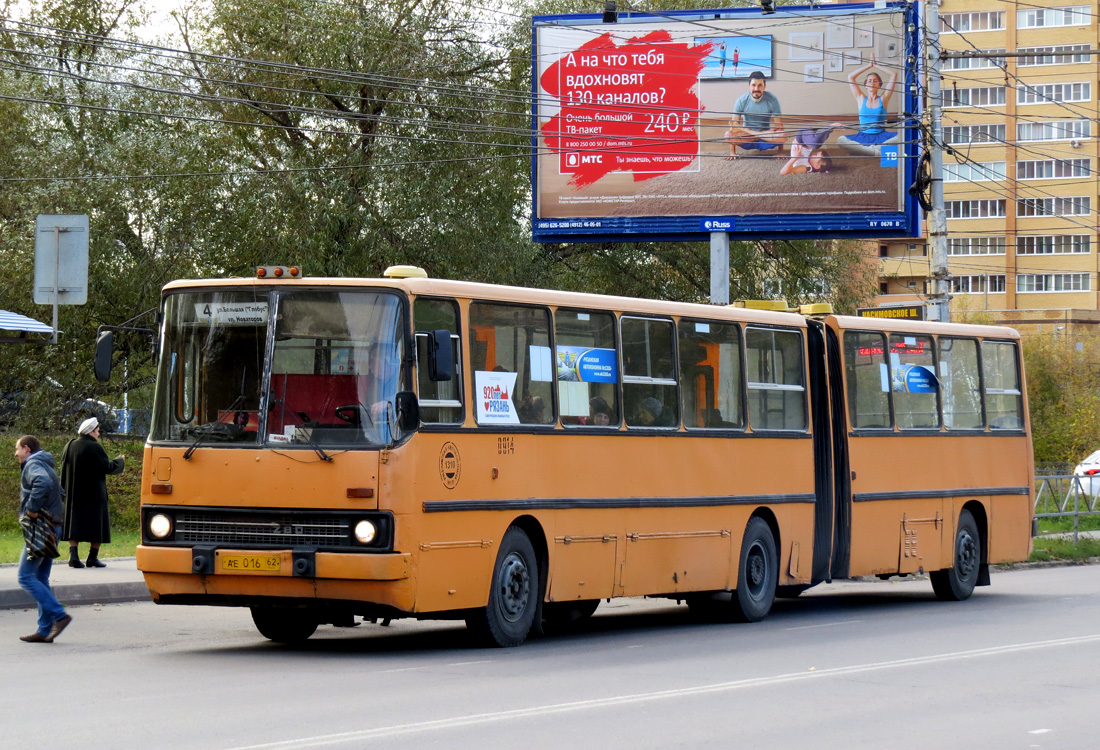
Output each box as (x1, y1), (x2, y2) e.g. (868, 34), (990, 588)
(413, 297), (465, 424)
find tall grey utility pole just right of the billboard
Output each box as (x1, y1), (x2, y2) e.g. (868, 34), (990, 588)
(925, 2), (952, 323)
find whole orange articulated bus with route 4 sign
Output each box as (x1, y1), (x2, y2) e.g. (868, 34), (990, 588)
(107, 267), (1033, 646)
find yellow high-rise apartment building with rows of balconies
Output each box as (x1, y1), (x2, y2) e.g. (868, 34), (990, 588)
(877, 0), (1100, 334)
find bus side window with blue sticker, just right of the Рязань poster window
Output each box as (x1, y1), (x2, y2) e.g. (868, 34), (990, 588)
(554, 309), (620, 427)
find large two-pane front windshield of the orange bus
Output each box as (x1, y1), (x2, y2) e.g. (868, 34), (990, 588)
(151, 289), (405, 450)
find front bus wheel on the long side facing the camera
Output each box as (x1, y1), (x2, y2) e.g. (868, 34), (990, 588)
(466, 526), (539, 648)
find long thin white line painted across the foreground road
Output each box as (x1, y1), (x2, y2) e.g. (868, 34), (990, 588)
(218, 633), (1100, 750)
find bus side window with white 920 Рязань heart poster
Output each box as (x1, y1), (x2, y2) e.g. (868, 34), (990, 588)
(470, 302), (554, 424)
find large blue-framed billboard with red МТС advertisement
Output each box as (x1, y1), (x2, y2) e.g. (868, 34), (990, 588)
(532, 3), (921, 242)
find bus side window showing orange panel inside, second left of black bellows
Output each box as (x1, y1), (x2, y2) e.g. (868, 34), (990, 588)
(679, 320), (745, 429)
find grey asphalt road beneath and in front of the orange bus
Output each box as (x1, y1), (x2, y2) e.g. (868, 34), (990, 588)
(0, 566), (1100, 750)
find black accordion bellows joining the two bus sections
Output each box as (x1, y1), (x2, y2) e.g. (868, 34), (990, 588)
(806, 320), (851, 583)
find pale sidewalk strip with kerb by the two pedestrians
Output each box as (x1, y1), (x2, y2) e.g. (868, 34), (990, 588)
(0, 556), (150, 609)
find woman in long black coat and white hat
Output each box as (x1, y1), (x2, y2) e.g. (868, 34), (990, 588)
(62, 417), (125, 567)
